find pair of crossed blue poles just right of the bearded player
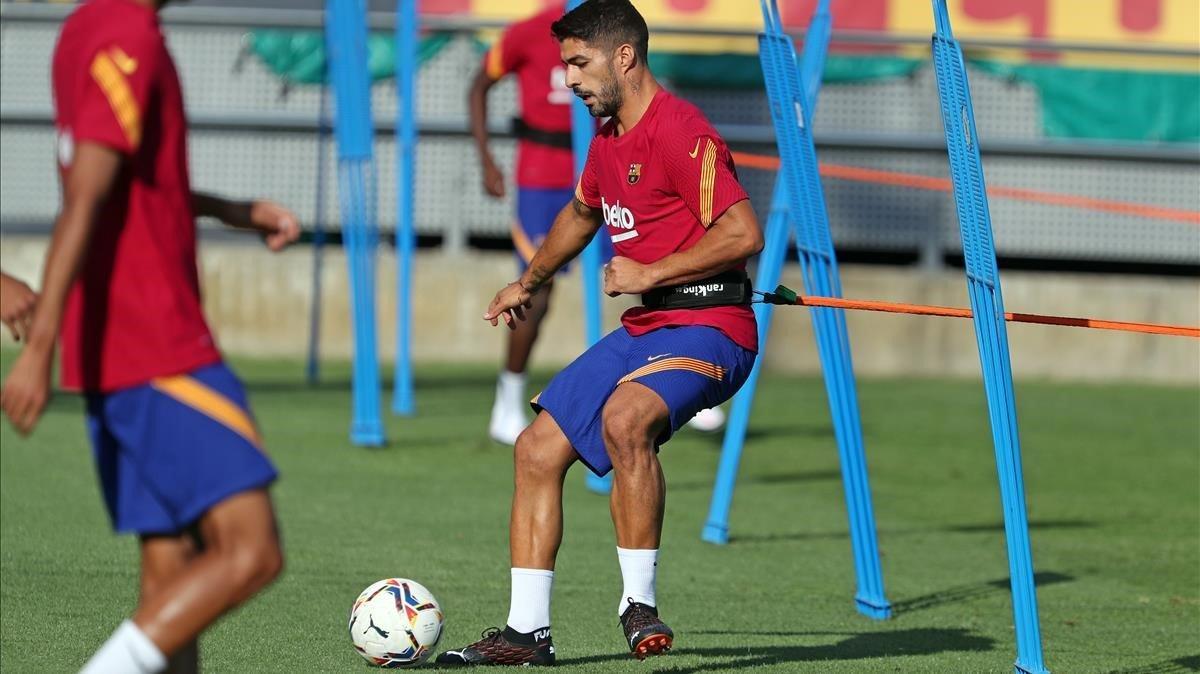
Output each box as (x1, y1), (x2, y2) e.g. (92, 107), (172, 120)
(701, 0), (892, 619)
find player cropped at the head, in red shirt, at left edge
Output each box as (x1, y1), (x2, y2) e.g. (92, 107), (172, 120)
(0, 0), (299, 674)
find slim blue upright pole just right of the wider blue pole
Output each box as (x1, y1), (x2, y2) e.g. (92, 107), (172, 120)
(391, 0), (416, 416)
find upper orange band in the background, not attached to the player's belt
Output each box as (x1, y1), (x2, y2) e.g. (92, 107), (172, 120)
(733, 152), (1200, 224)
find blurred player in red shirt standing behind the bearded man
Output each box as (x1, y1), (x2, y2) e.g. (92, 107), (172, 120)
(468, 2), (725, 445)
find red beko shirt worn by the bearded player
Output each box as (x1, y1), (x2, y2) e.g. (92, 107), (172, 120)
(575, 90), (758, 351)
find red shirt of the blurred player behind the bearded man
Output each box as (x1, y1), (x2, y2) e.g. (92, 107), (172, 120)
(484, 2), (575, 188)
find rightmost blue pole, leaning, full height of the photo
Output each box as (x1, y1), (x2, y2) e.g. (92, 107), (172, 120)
(934, 0), (1048, 674)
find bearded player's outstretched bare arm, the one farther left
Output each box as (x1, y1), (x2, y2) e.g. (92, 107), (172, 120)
(484, 198), (601, 327)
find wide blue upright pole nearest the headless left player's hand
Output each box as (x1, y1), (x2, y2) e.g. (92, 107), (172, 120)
(325, 0), (384, 446)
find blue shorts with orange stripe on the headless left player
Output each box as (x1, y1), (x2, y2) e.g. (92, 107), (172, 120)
(86, 363), (277, 535)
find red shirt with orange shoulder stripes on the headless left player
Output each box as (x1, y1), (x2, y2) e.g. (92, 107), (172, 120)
(53, 0), (221, 392)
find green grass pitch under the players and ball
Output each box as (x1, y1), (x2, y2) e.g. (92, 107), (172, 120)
(0, 353), (1200, 674)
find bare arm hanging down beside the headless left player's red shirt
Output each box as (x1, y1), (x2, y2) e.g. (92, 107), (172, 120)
(0, 143), (121, 434)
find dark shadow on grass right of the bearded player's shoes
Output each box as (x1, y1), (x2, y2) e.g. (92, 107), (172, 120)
(559, 628), (995, 673)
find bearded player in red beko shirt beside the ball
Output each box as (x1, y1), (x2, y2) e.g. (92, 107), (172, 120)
(438, 0), (762, 664)
